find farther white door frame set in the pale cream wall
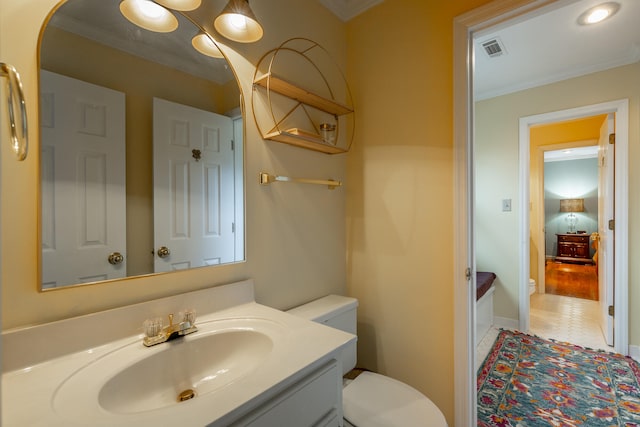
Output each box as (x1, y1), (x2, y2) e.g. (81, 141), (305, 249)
(518, 99), (629, 355)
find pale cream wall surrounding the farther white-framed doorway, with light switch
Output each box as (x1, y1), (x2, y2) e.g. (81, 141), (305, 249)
(476, 63), (640, 340)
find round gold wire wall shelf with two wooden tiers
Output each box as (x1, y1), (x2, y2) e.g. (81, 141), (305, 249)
(251, 38), (355, 154)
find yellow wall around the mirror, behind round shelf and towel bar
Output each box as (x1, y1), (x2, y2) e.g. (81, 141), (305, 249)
(0, 0), (346, 330)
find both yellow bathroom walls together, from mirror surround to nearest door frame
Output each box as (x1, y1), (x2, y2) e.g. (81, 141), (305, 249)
(0, 0), (544, 426)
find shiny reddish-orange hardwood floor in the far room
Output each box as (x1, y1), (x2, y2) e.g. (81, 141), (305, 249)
(545, 261), (598, 301)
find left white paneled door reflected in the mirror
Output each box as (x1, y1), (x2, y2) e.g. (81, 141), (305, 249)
(41, 70), (126, 288)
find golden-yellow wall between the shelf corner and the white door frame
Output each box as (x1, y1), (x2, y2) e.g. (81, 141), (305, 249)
(347, 0), (487, 425)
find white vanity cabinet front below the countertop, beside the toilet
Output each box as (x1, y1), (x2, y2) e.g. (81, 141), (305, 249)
(228, 360), (342, 427)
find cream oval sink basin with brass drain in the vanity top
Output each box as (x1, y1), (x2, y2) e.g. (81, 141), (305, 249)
(53, 319), (284, 414)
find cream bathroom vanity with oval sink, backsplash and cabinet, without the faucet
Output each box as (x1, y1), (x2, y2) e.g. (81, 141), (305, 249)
(2, 281), (356, 426)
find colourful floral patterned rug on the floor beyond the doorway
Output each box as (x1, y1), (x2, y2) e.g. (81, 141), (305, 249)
(478, 331), (640, 427)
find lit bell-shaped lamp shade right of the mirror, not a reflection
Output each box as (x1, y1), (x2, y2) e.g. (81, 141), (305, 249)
(213, 0), (263, 43)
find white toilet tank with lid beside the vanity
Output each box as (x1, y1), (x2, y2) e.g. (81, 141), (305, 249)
(287, 295), (358, 374)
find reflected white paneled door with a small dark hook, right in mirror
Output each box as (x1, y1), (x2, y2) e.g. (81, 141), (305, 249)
(153, 98), (234, 272)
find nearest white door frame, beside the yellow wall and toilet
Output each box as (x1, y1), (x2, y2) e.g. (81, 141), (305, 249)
(453, 0), (627, 427)
